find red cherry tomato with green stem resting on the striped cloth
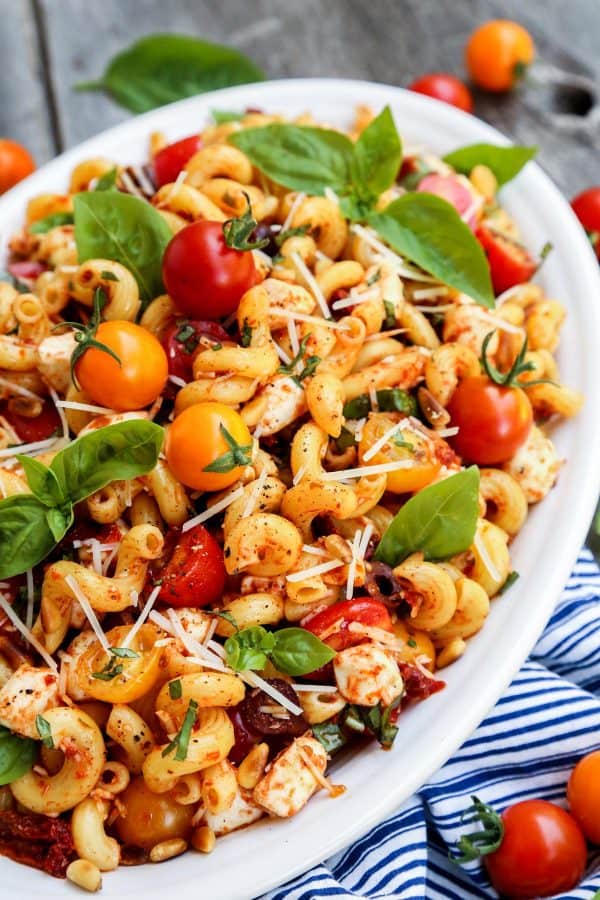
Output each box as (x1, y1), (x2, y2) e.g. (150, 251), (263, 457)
(485, 800), (587, 900)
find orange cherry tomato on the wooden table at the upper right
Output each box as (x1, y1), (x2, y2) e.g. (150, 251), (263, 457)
(465, 19), (535, 92)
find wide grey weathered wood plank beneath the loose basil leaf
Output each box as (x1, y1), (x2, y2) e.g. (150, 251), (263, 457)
(41, 0), (600, 193)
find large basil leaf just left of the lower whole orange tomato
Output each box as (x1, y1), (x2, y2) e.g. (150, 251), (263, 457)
(50, 419), (164, 504)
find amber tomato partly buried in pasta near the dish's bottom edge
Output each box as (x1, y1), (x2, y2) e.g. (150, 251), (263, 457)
(115, 775), (196, 850)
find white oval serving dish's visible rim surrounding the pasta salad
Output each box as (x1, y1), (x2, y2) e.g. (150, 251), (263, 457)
(0, 79), (600, 900)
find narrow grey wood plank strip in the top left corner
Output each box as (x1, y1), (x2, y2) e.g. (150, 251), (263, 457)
(0, 0), (56, 163)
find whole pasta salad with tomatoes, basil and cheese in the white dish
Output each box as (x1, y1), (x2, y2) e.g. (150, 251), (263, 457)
(0, 107), (582, 890)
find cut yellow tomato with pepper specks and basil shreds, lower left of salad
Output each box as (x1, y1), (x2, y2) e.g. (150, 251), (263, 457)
(77, 625), (162, 703)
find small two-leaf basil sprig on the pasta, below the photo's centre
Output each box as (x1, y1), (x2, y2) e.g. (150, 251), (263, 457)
(225, 625), (335, 675)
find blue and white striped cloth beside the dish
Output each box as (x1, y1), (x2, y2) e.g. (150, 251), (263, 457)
(262, 550), (600, 900)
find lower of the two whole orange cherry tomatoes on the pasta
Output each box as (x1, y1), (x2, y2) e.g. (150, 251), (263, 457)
(165, 402), (252, 491)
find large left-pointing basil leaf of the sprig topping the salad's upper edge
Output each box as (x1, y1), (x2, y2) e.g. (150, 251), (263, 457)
(227, 122), (353, 194)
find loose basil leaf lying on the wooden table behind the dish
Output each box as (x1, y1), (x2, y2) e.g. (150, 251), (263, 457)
(75, 34), (264, 113)
